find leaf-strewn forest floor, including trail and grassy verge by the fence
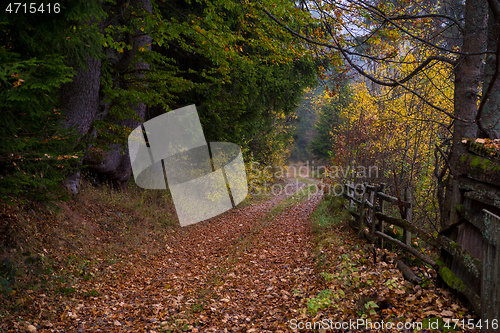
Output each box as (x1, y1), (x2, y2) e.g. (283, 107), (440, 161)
(6, 175), (478, 333)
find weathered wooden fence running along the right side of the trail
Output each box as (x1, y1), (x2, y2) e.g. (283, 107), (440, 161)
(344, 182), (500, 332)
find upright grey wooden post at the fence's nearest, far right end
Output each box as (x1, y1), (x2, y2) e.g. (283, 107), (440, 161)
(481, 209), (500, 333)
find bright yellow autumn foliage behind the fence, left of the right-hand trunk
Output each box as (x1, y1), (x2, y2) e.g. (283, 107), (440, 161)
(332, 50), (453, 220)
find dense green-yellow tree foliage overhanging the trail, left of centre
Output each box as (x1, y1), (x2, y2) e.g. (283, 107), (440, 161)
(153, 0), (318, 166)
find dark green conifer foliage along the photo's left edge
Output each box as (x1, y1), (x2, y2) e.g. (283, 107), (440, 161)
(0, 0), (103, 204)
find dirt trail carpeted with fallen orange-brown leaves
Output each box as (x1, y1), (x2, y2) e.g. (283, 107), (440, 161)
(58, 178), (320, 332)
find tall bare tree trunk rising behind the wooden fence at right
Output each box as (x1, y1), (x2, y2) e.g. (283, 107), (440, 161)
(440, 0), (488, 311)
